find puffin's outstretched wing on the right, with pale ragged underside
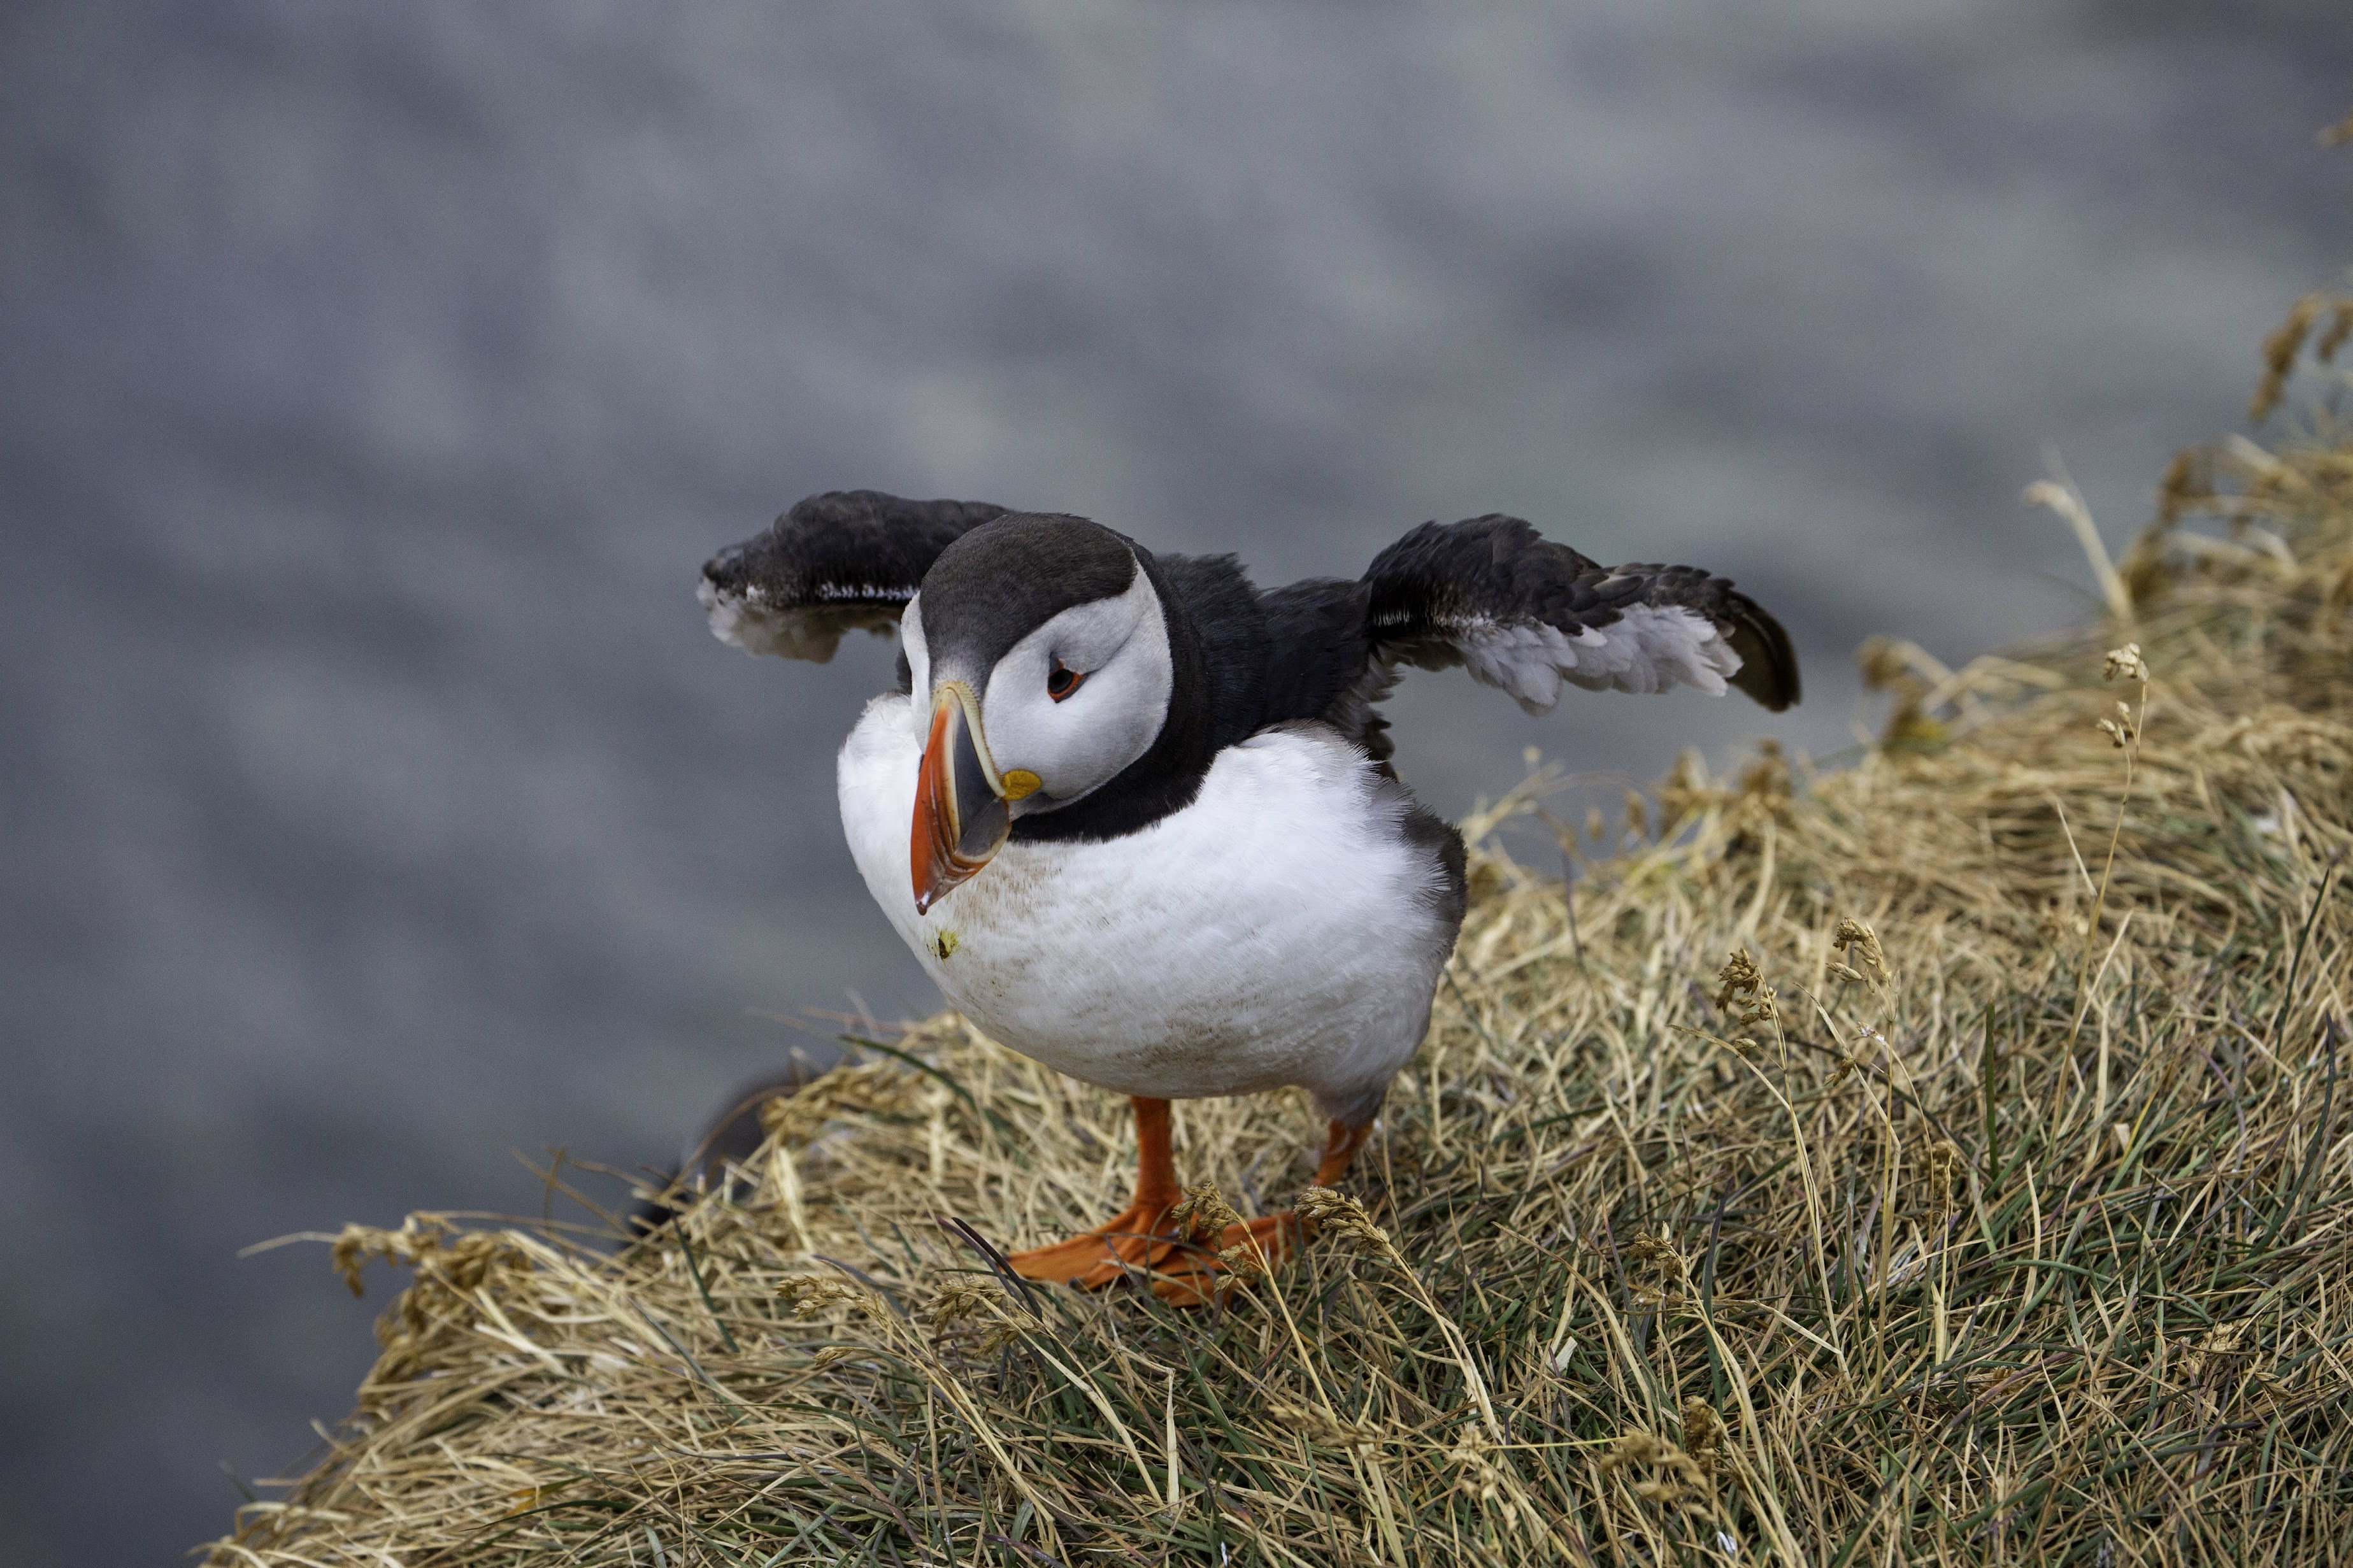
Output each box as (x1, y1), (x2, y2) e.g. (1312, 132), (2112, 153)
(1365, 516), (1798, 713)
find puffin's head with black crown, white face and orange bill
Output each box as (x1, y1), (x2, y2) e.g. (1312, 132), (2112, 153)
(901, 513), (1176, 913)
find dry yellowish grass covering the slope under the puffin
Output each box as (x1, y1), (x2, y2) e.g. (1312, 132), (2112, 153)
(210, 311), (2353, 1568)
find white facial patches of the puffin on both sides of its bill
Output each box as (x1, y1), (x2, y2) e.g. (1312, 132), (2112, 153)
(901, 567), (1176, 815)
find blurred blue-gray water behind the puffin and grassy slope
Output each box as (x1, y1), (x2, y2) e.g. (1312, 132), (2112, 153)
(0, 0), (2353, 1564)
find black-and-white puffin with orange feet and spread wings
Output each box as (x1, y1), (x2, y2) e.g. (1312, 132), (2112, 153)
(699, 490), (1798, 1304)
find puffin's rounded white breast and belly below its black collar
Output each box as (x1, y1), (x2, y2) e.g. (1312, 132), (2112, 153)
(840, 695), (1454, 1121)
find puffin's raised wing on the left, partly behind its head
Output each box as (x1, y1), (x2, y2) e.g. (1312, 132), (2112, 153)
(696, 490), (1005, 664)
